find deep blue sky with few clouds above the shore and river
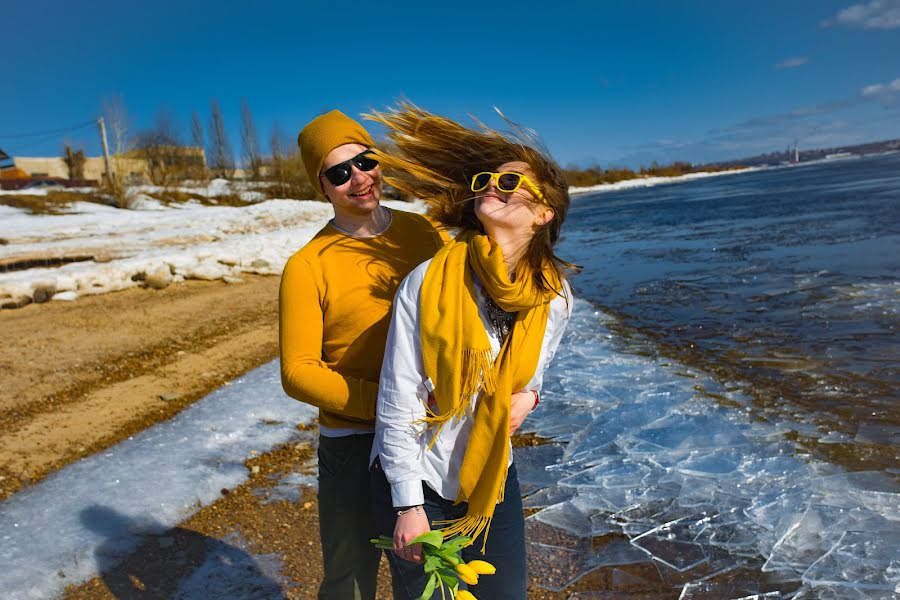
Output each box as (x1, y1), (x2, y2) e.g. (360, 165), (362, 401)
(0, 0), (900, 166)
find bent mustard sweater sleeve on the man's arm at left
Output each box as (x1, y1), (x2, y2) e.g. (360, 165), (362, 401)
(278, 258), (378, 420)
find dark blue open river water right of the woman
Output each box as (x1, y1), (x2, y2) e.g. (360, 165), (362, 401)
(559, 154), (900, 467)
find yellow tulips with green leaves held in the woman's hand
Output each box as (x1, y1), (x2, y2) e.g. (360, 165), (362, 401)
(371, 529), (497, 600)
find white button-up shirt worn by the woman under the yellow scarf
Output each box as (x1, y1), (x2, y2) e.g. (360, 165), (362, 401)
(371, 260), (573, 506)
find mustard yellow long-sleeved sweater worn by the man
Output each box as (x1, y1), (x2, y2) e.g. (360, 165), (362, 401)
(279, 210), (444, 429)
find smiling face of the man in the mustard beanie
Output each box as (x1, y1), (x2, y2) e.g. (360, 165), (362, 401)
(319, 144), (382, 217)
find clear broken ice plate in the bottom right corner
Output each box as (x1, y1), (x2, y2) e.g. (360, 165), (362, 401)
(803, 529), (900, 590)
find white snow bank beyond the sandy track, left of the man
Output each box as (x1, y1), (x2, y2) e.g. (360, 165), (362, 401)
(0, 189), (425, 304)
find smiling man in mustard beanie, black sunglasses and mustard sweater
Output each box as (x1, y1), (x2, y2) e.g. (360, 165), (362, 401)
(279, 110), (443, 600)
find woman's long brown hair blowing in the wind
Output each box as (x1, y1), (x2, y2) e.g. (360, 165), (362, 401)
(364, 102), (577, 293)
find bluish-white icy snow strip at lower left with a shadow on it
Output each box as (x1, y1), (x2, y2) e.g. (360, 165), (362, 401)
(0, 361), (316, 599)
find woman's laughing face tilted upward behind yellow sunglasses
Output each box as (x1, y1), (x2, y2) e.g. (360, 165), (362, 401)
(475, 161), (553, 238)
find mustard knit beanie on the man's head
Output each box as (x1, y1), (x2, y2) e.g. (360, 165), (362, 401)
(297, 110), (375, 196)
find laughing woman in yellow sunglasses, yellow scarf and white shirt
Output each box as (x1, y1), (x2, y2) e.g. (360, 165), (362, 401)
(369, 105), (571, 600)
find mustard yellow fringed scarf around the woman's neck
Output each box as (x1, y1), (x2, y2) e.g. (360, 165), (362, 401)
(419, 232), (559, 552)
